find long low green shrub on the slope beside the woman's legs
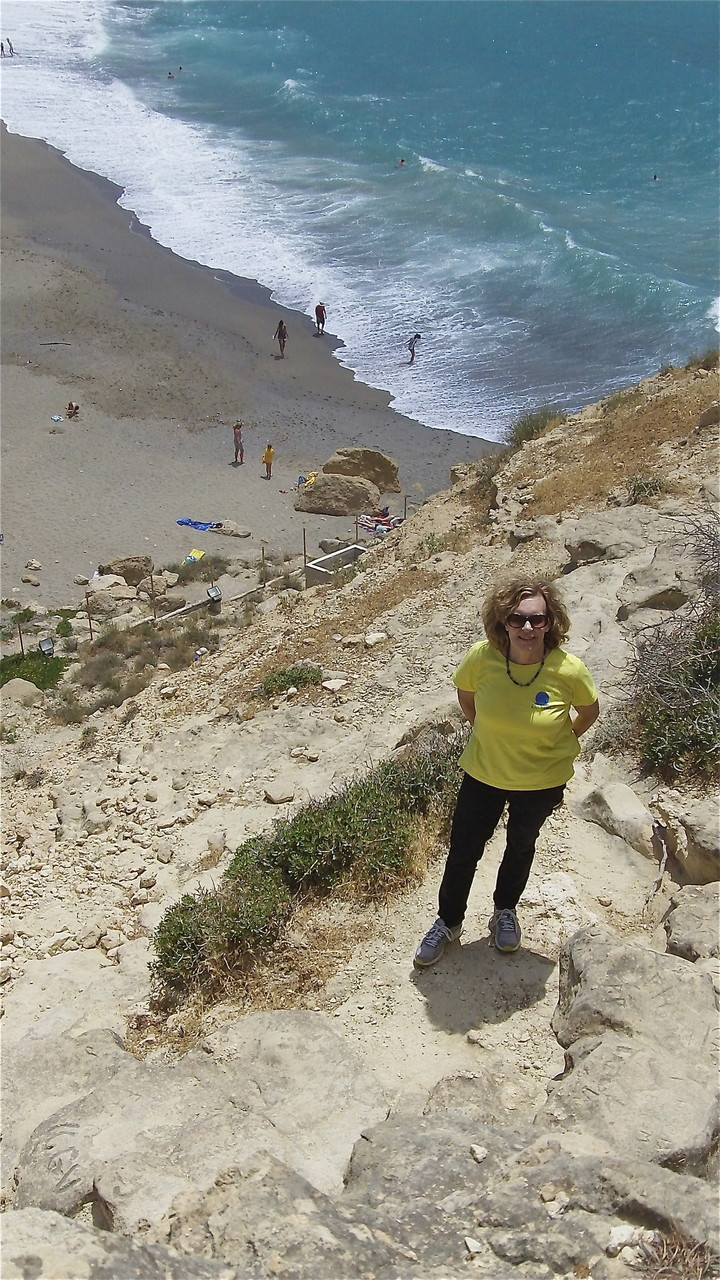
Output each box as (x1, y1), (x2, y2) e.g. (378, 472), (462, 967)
(152, 739), (460, 993)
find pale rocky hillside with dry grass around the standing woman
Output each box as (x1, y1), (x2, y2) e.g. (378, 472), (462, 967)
(0, 366), (720, 1280)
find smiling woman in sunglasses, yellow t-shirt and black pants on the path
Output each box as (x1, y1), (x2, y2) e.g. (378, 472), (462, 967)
(415, 579), (600, 968)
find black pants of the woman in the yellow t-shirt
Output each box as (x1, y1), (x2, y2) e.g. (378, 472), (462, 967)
(438, 773), (565, 929)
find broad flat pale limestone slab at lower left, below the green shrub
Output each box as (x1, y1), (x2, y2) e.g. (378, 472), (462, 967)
(15, 1008), (387, 1233)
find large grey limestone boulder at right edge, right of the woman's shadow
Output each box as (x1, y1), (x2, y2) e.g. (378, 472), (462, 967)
(538, 925), (719, 1175)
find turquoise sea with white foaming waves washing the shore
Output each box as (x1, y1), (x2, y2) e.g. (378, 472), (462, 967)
(0, 0), (719, 438)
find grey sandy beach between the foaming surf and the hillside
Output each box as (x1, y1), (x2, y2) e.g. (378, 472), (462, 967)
(1, 128), (496, 605)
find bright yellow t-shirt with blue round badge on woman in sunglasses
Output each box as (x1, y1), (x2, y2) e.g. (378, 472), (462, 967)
(452, 640), (597, 791)
